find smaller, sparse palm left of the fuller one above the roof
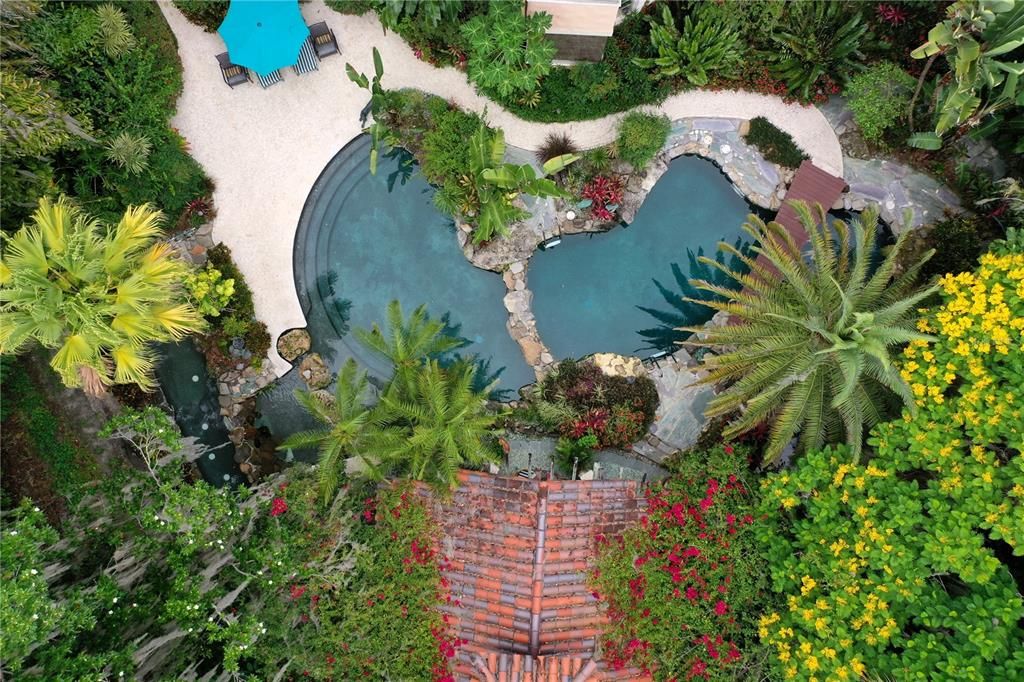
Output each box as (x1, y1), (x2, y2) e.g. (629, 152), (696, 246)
(278, 358), (373, 504)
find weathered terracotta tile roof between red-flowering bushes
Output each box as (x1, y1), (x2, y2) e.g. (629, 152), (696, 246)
(419, 471), (644, 682)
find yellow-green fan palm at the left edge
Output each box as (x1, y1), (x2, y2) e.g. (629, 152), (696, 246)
(0, 197), (203, 394)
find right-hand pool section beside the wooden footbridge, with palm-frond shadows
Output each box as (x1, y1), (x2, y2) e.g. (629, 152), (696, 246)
(527, 157), (756, 357)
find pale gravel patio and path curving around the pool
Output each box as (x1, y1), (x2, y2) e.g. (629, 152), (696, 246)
(160, 0), (843, 375)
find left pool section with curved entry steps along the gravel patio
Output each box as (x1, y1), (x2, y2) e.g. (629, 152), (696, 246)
(294, 135), (534, 391)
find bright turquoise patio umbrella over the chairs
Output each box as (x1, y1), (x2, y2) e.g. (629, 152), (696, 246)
(217, 0), (309, 76)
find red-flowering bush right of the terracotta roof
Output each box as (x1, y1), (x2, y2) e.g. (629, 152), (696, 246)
(590, 444), (766, 680)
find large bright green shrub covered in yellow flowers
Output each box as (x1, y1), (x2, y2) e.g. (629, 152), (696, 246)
(759, 242), (1024, 681)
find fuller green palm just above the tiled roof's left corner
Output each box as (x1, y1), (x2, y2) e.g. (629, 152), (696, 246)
(368, 360), (496, 489)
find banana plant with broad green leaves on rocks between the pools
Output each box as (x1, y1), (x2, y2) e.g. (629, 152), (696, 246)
(462, 125), (580, 244)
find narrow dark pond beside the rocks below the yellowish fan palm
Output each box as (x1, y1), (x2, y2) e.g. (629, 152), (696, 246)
(157, 340), (242, 485)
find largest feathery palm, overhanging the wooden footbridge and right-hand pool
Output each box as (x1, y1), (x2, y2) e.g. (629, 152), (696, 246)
(684, 202), (935, 461)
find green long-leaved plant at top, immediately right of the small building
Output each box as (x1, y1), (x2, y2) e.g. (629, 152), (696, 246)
(633, 4), (743, 86)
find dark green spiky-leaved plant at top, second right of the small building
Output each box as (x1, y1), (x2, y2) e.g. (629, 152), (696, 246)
(771, 0), (867, 101)
